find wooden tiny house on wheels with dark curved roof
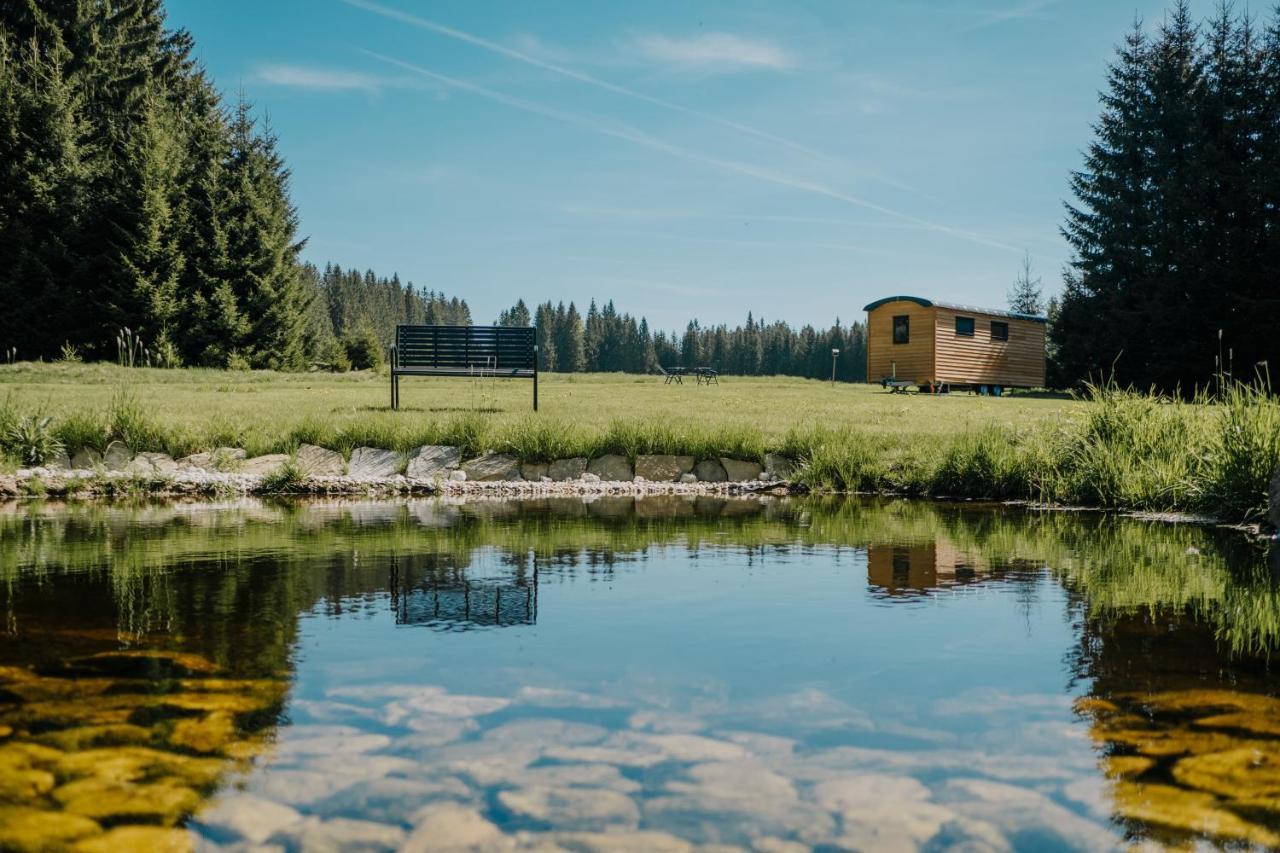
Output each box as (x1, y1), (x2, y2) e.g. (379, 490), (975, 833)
(864, 296), (1044, 394)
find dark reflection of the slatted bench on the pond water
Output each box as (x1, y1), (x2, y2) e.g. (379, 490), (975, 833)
(390, 561), (538, 630)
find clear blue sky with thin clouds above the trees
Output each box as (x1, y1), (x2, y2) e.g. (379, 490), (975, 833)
(168, 0), (1210, 329)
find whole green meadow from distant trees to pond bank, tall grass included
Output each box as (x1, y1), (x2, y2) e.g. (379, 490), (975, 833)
(0, 364), (1280, 519)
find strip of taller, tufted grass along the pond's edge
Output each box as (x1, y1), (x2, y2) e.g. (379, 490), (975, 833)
(0, 382), (1280, 520)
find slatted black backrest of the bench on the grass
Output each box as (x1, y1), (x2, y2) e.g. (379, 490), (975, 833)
(396, 325), (538, 370)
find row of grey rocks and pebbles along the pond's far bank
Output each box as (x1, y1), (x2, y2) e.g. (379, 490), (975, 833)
(0, 442), (803, 497)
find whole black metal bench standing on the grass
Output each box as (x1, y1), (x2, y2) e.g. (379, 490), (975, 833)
(392, 325), (538, 411)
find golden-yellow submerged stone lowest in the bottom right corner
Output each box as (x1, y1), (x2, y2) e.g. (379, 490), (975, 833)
(1114, 781), (1280, 848)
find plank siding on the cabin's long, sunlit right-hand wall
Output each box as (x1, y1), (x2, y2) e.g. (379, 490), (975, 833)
(936, 306), (1044, 388)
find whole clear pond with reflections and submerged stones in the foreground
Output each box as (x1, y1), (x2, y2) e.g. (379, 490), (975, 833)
(0, 497), (1280, 850)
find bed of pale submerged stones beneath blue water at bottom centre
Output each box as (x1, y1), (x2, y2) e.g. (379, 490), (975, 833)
(209, 683), (1116, 853)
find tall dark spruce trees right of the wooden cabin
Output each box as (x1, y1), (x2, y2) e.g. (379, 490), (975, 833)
(1050, 1), (1280, 392)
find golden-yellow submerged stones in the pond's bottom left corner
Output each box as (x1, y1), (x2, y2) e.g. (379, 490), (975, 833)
(0, 649), (287, 853)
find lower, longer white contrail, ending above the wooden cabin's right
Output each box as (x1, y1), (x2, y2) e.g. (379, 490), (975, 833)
(366, 50), (1023, 255)
